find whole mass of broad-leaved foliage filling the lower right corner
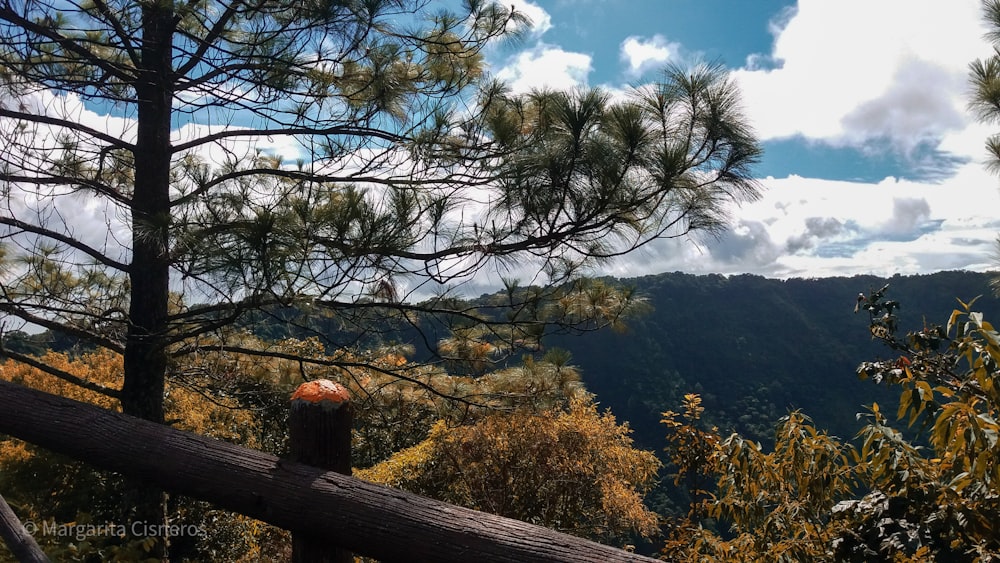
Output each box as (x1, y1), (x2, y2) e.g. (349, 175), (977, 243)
(665, 287), (1000, 561)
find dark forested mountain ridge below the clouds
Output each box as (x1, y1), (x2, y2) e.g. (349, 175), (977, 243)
(545, 272), (1000, 450)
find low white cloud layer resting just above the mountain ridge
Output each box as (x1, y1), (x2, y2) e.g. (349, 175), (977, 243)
(588, 163), (1000, 278)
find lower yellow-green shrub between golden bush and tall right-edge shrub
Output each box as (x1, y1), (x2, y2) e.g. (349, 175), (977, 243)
(664, 395), (863, 561)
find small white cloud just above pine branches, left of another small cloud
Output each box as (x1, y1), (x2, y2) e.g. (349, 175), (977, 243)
(497, 43), (593, 93)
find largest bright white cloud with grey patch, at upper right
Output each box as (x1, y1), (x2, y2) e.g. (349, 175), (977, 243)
(735, 0), (990, 152)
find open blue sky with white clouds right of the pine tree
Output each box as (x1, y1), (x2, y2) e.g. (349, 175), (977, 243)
(489, 0), (1000, 278)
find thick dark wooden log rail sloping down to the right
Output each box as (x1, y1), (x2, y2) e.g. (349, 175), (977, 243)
(0, 381), (655, 563)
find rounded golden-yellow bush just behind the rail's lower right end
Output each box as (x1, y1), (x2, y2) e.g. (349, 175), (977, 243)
(356, 401), (659, 539)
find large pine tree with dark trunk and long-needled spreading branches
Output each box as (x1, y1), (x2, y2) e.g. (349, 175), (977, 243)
(0, 0), (760, 556)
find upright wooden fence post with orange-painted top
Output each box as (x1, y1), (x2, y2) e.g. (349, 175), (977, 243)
(288, 379), (354, 563)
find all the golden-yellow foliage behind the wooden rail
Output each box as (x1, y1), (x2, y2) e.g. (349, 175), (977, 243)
(0, 335), (659, 559)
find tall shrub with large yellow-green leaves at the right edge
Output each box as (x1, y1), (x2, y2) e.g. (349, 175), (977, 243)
(859, 288), (1000, 560)
